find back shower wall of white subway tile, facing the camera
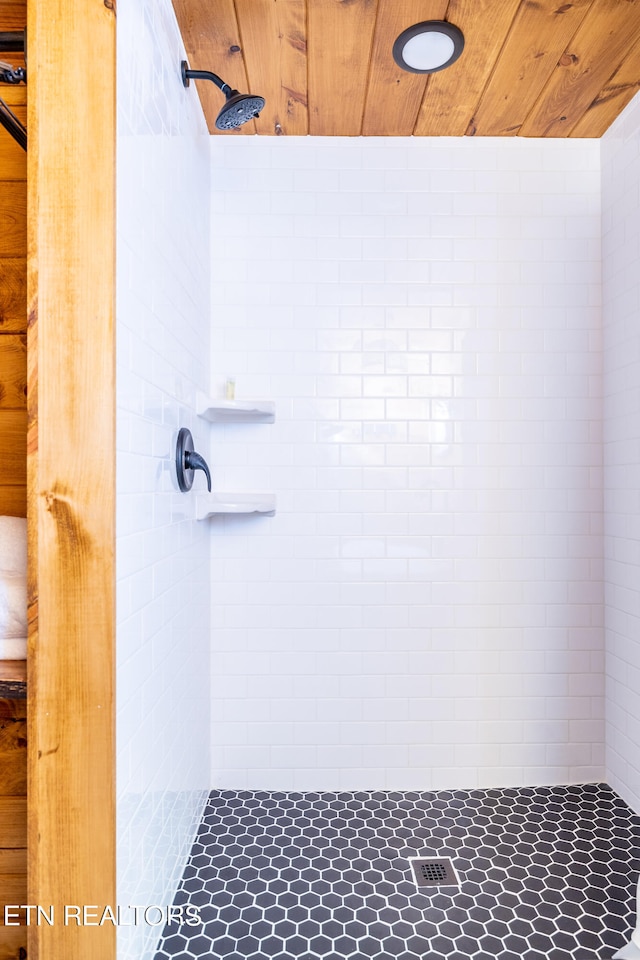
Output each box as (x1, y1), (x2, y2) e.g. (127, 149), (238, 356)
(211, 137), (604, 790)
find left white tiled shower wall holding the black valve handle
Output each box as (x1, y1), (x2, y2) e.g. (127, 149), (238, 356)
(116, 0), (210, 960)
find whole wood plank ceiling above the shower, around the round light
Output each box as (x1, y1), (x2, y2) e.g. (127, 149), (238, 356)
(173, 0), (640, 137)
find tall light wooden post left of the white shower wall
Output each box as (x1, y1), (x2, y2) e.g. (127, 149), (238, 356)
(27, 0), (116, 960)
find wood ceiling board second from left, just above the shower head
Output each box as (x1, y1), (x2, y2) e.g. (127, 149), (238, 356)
(238, 0), (309, 136)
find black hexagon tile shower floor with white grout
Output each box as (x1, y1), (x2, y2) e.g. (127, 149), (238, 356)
(156, 784), (640, 960)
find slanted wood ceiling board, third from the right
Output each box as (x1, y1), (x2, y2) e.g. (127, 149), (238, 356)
(469, 0), (599, 137)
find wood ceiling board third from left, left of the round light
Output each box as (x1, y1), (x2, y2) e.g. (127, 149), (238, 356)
(307, 0), (378, 137)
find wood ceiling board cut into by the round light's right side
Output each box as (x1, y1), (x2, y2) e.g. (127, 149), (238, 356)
(414, 0), (520, 137)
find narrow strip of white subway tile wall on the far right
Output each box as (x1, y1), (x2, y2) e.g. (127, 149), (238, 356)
(602, 90), (640, 811)
